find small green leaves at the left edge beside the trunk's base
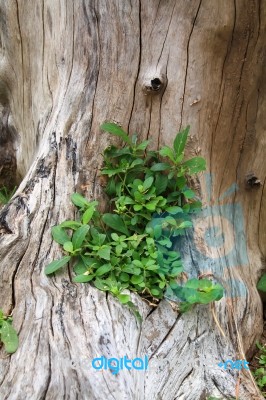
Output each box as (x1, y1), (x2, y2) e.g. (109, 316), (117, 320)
(0, 310), (19, 353)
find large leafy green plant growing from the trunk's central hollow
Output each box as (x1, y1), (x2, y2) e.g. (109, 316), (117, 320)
(45, 123), (222, 318)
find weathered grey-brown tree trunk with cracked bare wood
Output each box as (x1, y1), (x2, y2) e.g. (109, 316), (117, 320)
(0, 0), (266, 400)
